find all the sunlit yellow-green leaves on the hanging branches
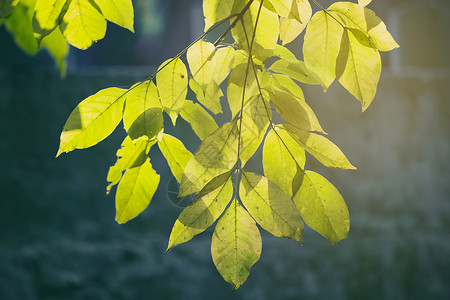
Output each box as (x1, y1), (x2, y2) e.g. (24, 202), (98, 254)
(5, 0), (398, 289)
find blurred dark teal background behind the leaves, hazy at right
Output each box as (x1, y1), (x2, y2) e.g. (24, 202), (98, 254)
(0, 0), (450, 300)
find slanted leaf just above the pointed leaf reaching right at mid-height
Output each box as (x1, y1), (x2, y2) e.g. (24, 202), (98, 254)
(266, 86), (325, 133)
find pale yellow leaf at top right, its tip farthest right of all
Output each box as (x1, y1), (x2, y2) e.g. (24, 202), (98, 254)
(329, 2), (399, 51)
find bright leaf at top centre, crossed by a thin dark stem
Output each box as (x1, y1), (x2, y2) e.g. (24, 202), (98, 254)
(231, 1), (279, 60)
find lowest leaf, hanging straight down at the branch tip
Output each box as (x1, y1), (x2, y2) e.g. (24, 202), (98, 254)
(211, 199), (262, 290)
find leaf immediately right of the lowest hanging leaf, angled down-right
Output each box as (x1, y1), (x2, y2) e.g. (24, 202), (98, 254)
(239, 172), (304, 243)
